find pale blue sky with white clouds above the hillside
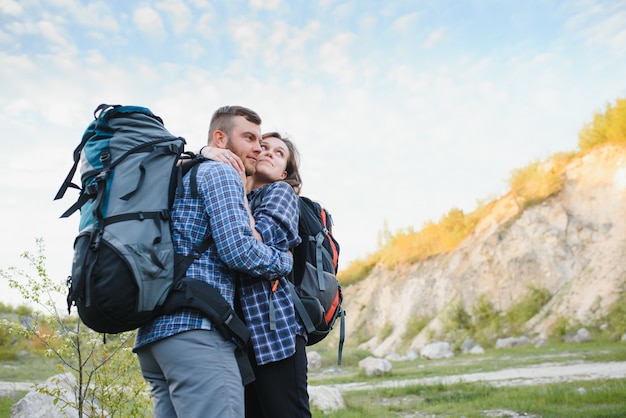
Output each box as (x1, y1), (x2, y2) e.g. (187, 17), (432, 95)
(0, 0), (626, 304)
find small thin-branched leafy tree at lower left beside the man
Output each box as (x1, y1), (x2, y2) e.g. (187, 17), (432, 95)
(0, 239), (151, 417)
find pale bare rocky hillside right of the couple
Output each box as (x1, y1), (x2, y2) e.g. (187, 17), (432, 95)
(344, 145), (626, 356)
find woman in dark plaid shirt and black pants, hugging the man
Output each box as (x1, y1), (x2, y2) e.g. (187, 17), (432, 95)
(201, 132), (311, 418)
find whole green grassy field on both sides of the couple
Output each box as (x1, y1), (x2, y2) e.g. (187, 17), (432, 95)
(0, 342), (626, 418)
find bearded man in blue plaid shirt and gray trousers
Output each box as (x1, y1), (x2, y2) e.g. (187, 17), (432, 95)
(135, 106), (292, 418)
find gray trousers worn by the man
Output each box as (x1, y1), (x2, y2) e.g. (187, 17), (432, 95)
(137, 330), (244, 418)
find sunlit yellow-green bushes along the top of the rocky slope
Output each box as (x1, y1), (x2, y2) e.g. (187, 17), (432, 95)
(338, 99), (626, 286)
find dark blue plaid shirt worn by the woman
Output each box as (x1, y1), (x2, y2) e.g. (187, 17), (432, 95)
(239, 181), (301, 365)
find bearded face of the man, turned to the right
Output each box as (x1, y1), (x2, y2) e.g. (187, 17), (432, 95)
(226, 116), (261, 176)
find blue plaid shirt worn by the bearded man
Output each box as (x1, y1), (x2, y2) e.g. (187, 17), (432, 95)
(135, 161), (292, 349)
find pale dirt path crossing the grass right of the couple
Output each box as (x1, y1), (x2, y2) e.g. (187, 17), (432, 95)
(329, 362), (626, 392)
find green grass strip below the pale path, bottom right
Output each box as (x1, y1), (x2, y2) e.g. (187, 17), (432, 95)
(314, 379), (626, 418)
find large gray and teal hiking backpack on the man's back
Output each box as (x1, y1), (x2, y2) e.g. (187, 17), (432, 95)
(55, 104), (254, 384)
